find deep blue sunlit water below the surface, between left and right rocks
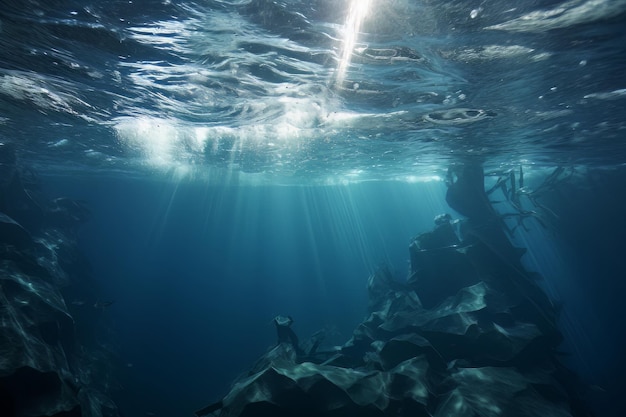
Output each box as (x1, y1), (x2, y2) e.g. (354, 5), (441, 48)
(48, 178), (446, 415)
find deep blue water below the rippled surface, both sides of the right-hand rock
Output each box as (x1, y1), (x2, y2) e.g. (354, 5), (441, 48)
(40, 169), (626, 415)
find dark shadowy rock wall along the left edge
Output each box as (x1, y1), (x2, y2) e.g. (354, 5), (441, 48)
(0, 148), (117, 417)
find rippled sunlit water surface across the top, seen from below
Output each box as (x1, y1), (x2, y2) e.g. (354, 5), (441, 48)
(0, 0), (626, 183)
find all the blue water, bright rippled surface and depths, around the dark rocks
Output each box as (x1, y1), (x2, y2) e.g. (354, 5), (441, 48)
(0, 0), (626, 416)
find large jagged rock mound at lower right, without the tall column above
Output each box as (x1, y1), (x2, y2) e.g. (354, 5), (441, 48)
(197, 219), (588, 417)
